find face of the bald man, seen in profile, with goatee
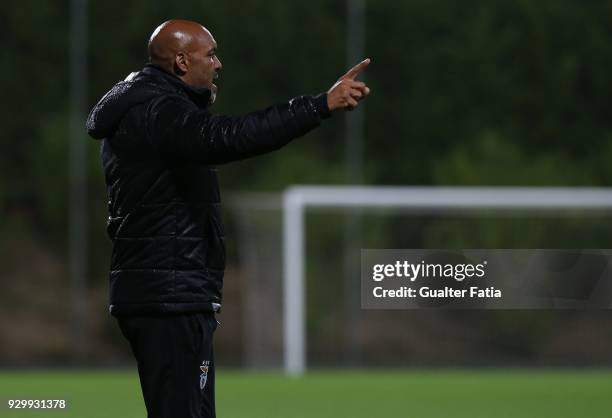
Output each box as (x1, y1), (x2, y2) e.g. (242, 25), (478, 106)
(189, 30), (223, 103)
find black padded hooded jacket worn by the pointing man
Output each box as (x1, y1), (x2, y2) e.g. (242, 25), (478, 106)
(87, 64), (330, 316)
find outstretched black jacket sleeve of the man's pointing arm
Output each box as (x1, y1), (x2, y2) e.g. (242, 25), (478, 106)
(148, 93), (330, 164)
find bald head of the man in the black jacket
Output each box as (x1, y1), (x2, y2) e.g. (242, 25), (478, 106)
(149, 20), (222, 96)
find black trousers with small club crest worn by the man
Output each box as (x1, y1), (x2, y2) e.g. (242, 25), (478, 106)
(117, 312), (218, 418)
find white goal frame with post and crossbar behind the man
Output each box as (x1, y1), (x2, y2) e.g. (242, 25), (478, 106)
(283, 186), (612, 376)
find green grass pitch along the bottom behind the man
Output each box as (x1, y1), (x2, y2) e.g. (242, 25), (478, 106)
(0, 370), (612, 418)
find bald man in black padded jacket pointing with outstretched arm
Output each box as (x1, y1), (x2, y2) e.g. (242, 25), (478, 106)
(87, 20), (370, 418)
